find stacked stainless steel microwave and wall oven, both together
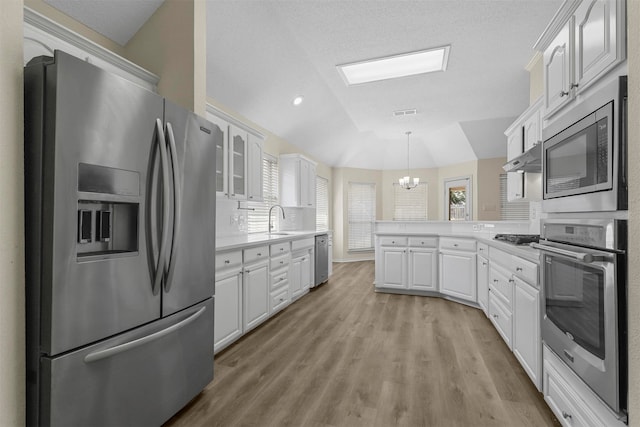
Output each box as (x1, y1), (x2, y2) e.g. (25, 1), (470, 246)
(533, 77), (628, 418)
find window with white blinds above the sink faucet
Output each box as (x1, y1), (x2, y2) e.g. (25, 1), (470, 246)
(247, 154), (280, 233)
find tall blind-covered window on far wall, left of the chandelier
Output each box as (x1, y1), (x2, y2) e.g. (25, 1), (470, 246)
(348, 182), (376, 251)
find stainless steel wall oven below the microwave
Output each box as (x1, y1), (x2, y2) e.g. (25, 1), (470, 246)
(533, 219), (627, 418)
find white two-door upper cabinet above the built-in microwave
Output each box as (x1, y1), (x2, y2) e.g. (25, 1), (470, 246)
(535, 0), (626, 118)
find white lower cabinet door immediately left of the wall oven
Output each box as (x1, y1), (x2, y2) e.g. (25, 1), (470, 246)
(513, 278), (542, 390)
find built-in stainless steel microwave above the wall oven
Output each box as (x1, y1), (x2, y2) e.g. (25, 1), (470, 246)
(542, 76), (627, 212)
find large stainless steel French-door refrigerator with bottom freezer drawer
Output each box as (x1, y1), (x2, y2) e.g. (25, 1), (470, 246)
(24, 51), (222, 426)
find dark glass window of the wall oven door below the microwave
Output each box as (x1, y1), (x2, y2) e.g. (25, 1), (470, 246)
(544, 254), (607, 360)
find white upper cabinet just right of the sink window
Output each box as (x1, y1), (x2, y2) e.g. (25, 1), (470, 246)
(280, 154), (316, 208)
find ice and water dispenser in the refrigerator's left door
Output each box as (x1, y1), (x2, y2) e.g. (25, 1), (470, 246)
(76, 163), (140, 260)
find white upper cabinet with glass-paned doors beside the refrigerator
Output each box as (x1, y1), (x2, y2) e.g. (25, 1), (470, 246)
(206, 105), (264, 201)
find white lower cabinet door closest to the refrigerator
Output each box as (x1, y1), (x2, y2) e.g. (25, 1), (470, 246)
(213, 272), (242, 351)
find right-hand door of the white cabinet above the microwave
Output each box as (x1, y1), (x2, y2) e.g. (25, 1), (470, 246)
(574, 0), (625, 92)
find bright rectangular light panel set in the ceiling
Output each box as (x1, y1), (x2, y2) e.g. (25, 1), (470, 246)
(337, 46), (451, 85)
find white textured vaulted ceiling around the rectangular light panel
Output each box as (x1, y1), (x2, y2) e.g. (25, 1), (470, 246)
(45, 0), (562, 169)
